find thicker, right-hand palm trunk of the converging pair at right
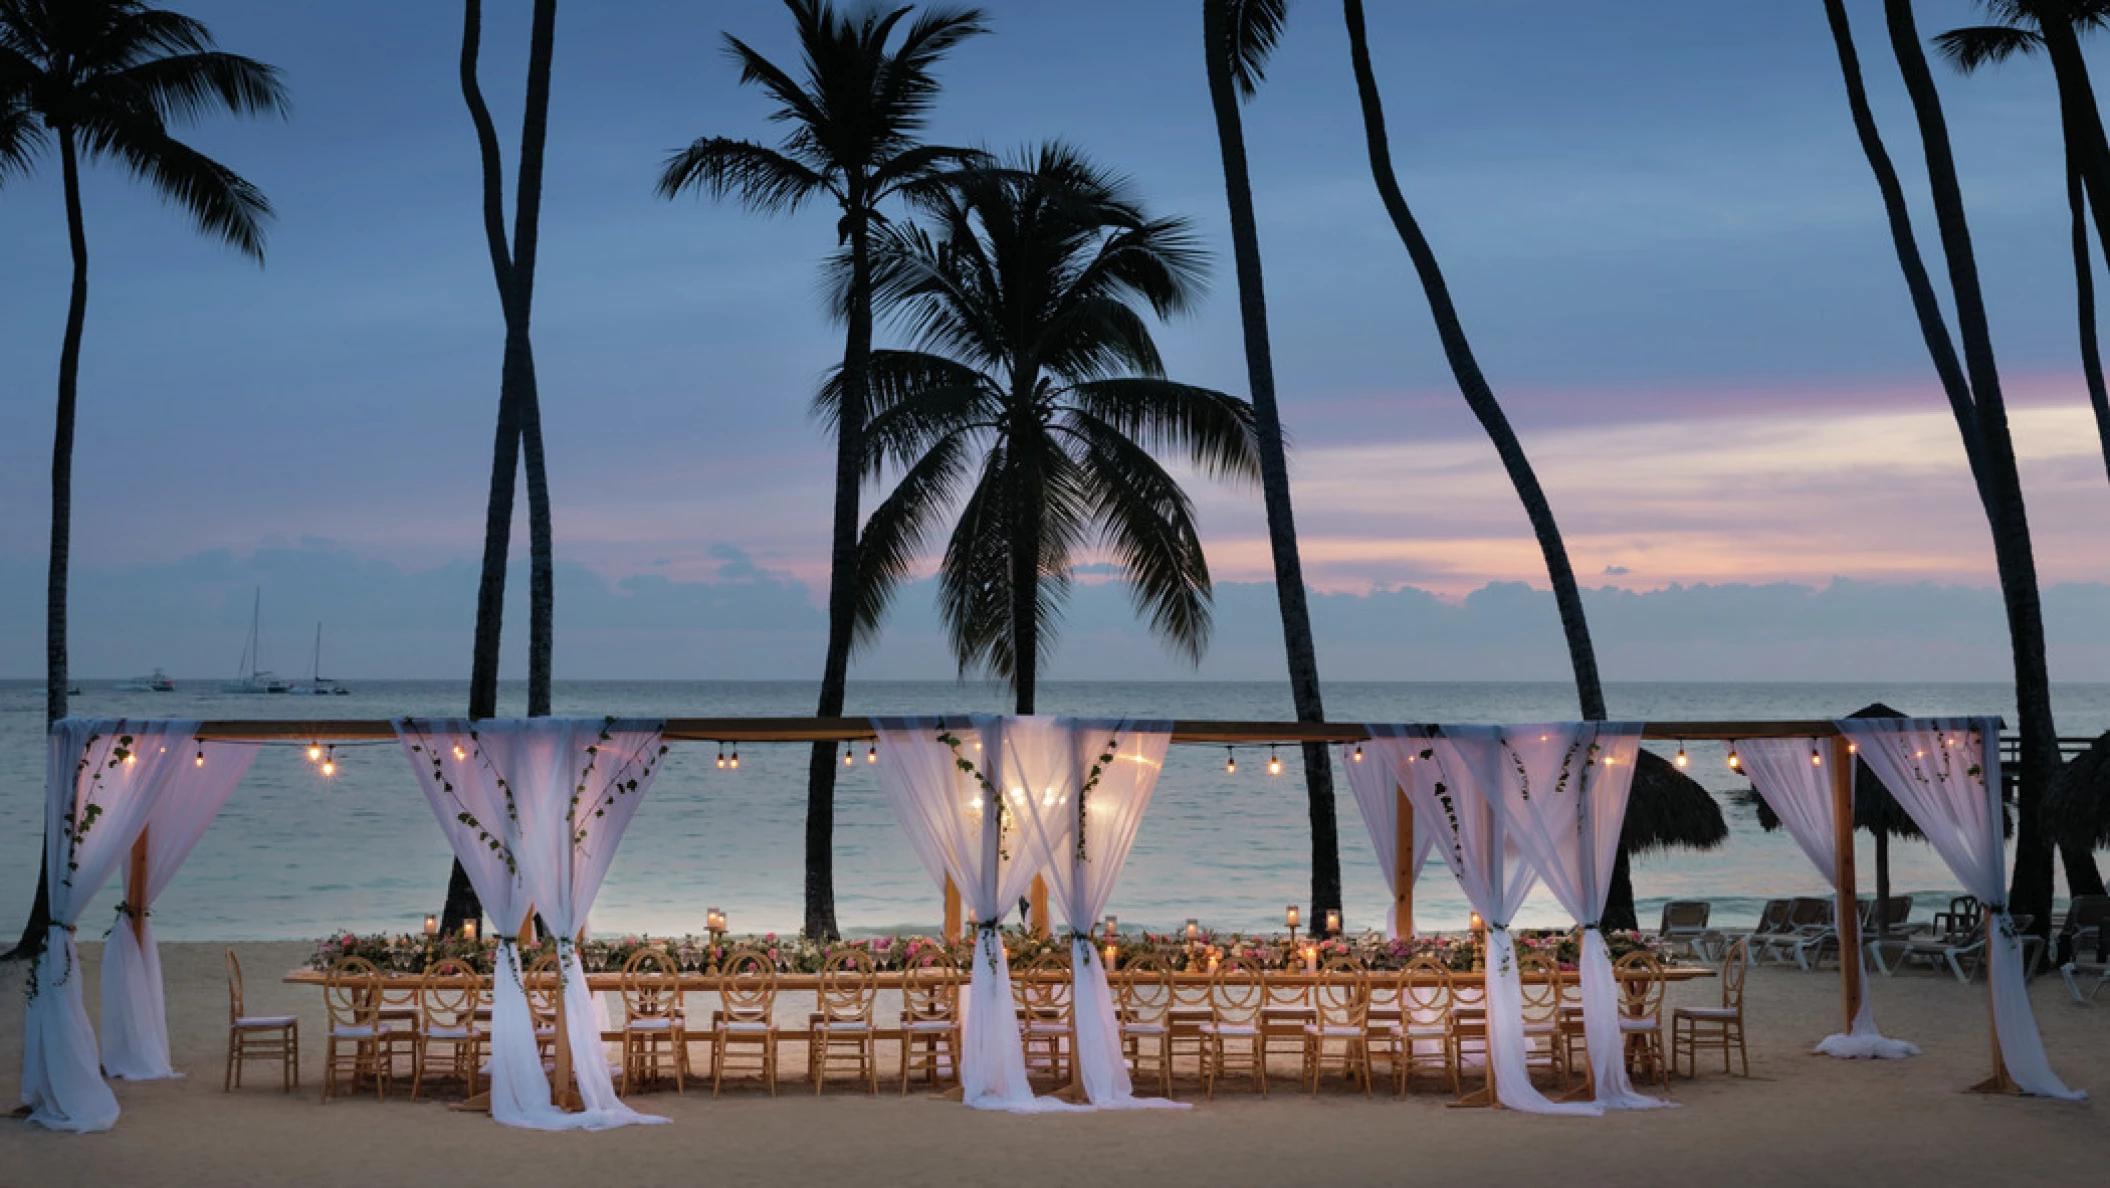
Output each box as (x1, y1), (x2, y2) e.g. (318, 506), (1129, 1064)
(1882, 0), (2093, 937)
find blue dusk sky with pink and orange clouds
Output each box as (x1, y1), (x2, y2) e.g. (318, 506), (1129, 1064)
(0, 0), (2110, 679)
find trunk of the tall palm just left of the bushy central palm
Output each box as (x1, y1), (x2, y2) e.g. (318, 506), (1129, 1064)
(806, 218), (871, 941)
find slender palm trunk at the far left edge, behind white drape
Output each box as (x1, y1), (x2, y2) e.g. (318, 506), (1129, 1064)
(0, 124), (89, 960)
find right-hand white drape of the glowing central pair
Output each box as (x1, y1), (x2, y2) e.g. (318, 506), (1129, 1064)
(1002, 717), (1188, 1110)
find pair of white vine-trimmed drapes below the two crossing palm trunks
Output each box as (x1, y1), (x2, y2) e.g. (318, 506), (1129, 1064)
(397, 717), (665, 1131)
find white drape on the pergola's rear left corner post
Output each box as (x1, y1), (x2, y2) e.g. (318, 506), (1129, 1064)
(103, 741), (257, 1080)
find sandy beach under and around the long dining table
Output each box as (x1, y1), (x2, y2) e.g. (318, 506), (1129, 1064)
(0, 943), (2110, 1188)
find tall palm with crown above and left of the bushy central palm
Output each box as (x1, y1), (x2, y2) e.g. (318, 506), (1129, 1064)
(658, 0), (987, 939)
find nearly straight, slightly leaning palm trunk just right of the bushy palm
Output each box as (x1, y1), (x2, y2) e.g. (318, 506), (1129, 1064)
(1203, 2), (1340, 920)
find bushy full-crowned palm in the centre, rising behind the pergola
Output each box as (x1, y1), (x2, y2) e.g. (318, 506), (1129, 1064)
(839, 143), (1260, 713)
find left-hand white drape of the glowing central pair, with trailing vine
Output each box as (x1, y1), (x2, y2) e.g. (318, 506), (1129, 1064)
(871, 715), (1074, 1114)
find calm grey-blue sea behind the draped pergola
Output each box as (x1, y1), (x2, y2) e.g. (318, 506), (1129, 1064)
(0, 679), (2110, 941)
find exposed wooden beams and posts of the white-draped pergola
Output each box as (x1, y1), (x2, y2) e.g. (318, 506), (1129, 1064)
(164, 715), (2015, 1093)
